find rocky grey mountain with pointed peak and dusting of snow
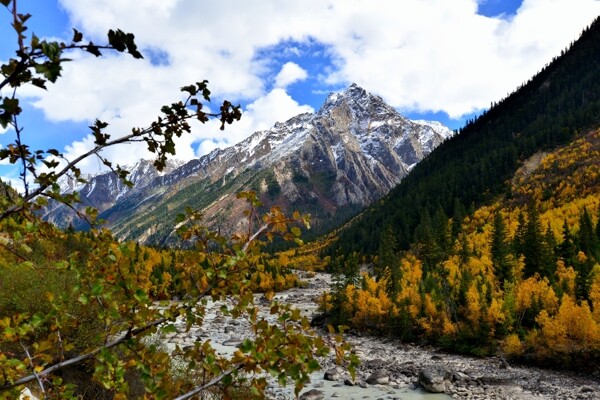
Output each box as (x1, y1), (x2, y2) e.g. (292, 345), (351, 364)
(47, 84), (452, 244)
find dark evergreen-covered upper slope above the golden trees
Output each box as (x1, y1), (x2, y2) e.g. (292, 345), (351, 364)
(329, 19), (600, 255)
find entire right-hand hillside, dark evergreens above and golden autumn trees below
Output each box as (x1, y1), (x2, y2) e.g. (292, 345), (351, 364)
(322, 15), (600, 368)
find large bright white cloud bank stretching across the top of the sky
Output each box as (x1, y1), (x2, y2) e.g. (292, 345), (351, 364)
(51, 0), (600, 117)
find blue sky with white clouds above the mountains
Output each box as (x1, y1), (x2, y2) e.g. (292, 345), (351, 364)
(0, 0), (600, 190)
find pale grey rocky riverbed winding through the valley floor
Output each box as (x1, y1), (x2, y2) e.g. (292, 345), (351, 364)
(161, 274), (600, 400)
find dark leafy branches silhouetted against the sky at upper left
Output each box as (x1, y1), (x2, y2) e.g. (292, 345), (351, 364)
(0, 1), (241, 219)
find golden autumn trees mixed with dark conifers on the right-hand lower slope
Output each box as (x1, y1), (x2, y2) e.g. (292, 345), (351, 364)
(324, 130), (600, 366)
